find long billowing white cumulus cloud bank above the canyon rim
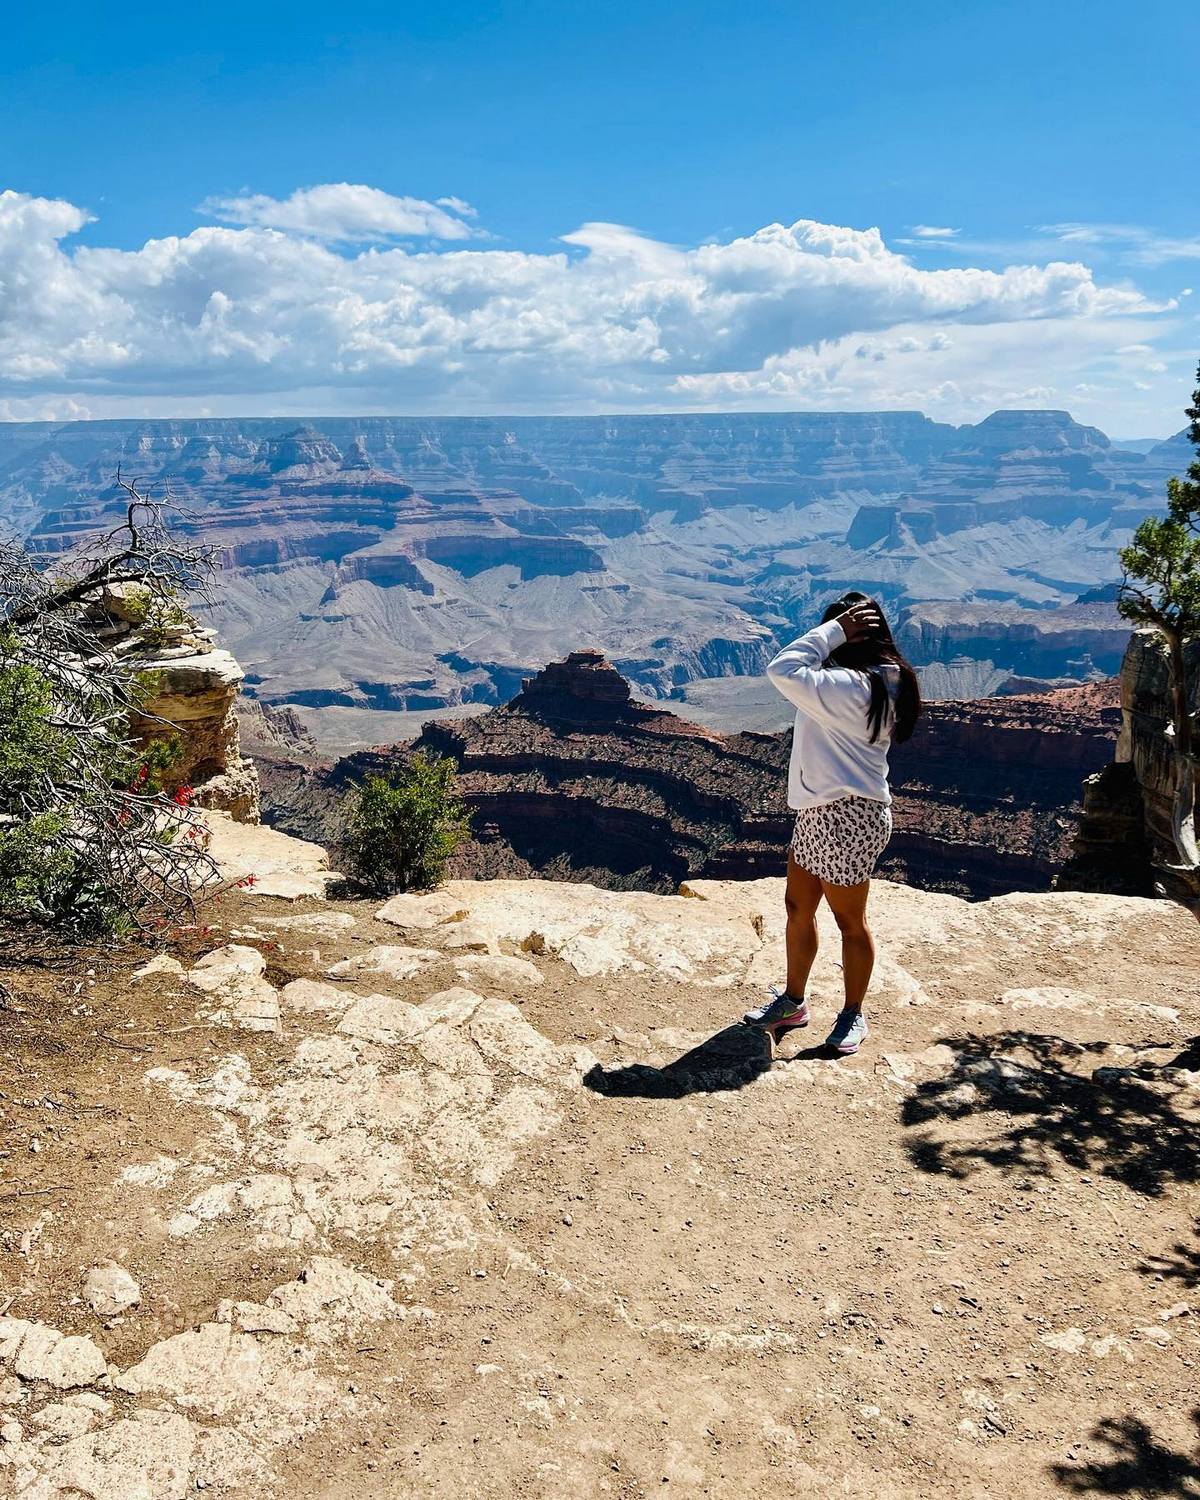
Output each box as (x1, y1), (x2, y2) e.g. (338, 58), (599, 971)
(0, 185), (1163, 426)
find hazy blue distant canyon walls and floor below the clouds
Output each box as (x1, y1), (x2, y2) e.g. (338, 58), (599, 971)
(0, 411), (1190, 752)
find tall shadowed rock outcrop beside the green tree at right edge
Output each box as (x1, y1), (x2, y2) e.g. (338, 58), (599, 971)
(1059, 627), (1200, 896)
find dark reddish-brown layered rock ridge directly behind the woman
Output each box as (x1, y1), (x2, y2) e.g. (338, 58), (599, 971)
(264, 651), (1119, 897)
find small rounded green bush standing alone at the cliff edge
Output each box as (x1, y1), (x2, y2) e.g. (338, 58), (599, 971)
(347, 752), (470, 896)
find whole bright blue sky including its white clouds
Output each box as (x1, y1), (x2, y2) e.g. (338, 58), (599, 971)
(0, 0), (1200, 437)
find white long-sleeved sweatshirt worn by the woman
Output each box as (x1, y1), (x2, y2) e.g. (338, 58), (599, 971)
(767, 620), (900, 809)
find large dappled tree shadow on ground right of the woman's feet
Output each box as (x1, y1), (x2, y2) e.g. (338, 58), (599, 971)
(902, 1031), (1200, 1197)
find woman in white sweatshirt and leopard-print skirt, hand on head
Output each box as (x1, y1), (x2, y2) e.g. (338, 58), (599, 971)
(744, 593), (921, 1053)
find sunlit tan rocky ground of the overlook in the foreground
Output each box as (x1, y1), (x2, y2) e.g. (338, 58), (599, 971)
(0, 819), (1200, 1500)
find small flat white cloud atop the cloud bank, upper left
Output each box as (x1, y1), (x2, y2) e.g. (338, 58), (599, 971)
(197, 183), (476, 243)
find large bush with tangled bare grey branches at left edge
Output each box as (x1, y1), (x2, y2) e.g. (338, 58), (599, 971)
(0, 489), (219, 942)
